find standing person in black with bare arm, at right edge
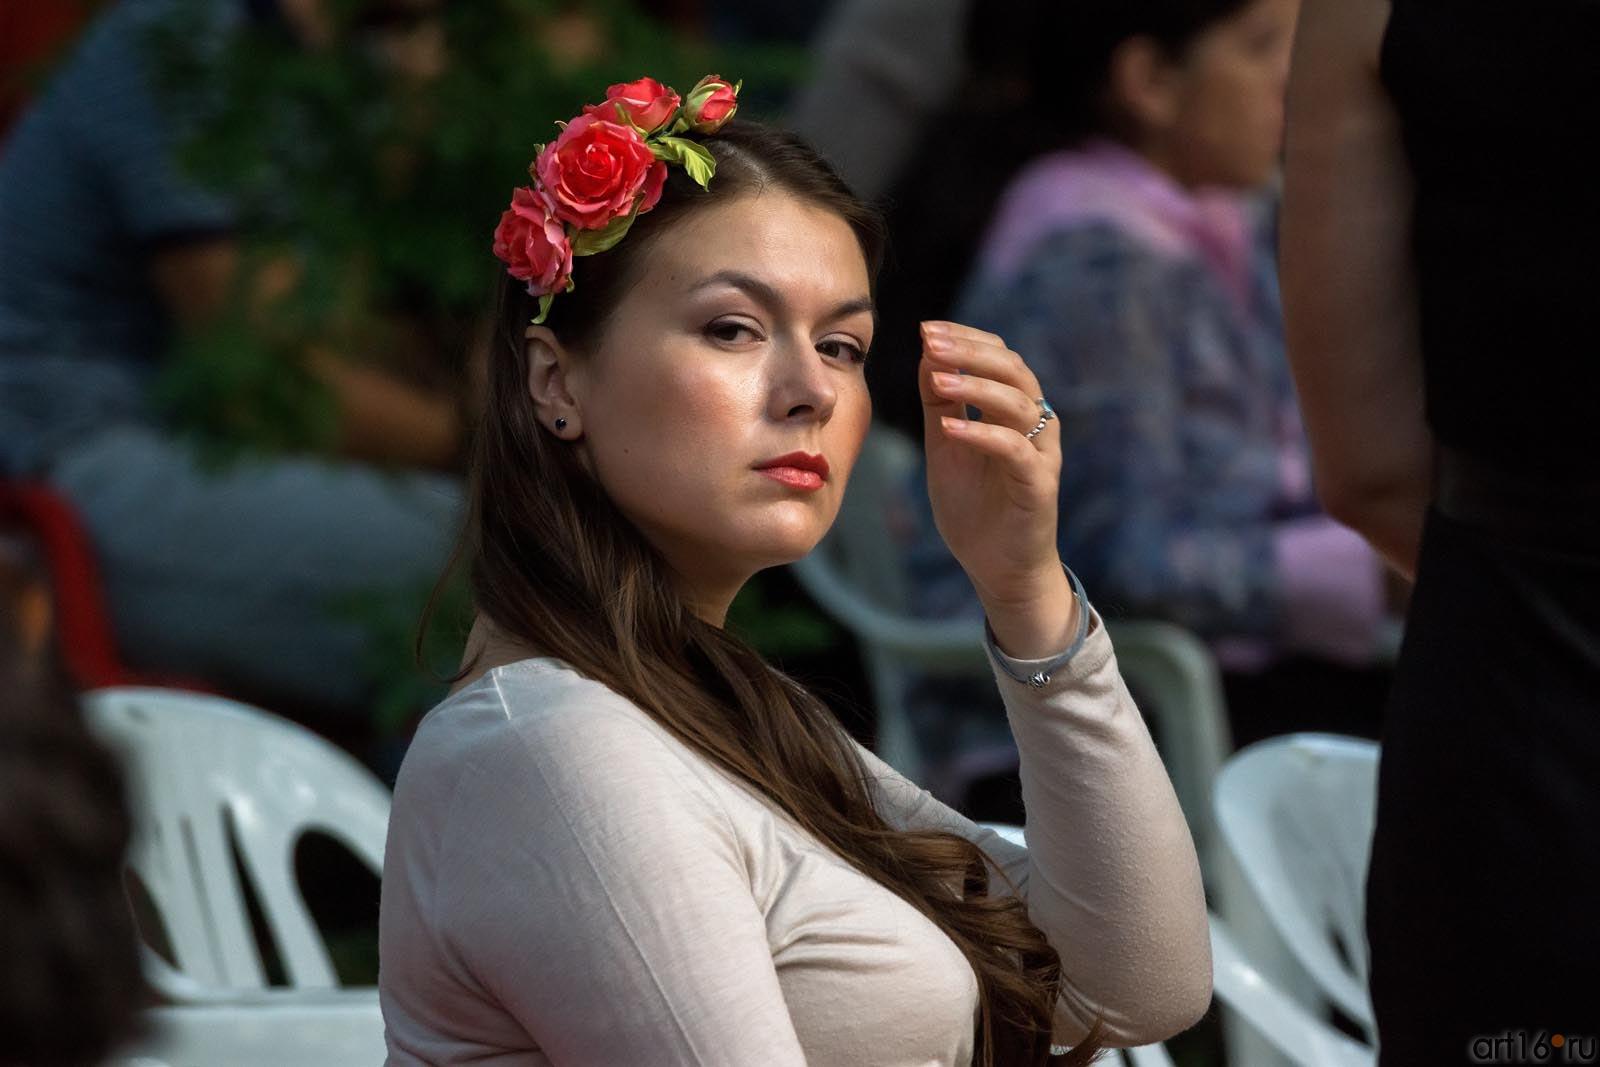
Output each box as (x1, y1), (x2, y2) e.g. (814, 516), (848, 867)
(1283, 0), (1600, 1067)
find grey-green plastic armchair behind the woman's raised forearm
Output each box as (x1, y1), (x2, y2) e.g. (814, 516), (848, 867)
(792, 426), (1234, 881)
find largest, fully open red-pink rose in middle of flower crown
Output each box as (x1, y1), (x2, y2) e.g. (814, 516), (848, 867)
(533, 115), (667, 230)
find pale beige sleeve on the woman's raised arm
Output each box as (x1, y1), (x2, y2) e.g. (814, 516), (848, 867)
(864, 616), (1211, 1046)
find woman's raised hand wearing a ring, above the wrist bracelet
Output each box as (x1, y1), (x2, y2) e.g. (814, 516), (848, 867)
(917, 322), (1077, 659)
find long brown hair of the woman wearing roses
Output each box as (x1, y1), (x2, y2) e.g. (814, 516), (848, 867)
(444, 122), (1101, 1067)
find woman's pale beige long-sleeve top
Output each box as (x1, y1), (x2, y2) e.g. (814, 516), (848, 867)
(379, 619), (1211, 1067)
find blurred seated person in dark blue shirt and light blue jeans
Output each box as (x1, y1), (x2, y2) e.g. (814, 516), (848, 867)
(0, 0), (462, 723)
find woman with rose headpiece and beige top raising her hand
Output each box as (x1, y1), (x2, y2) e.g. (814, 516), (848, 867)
(379, 78), (1210, 1065)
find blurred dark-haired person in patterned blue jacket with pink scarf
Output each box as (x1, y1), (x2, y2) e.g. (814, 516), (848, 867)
(896, 0), (1408, 819)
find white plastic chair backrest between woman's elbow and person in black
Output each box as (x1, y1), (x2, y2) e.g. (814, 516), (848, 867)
(1216, 734), (1378, 1033)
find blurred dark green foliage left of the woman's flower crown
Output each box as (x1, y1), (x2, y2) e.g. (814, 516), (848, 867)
(140, 0), (834, 733)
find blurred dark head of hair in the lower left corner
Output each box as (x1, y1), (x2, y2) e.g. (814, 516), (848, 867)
(0, 541), (144, 1067)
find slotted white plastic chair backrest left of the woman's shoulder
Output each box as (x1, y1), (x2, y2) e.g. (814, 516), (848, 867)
(83, 688), (390, 1000)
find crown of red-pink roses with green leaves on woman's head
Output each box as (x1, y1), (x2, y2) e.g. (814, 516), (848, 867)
(494, 74), (744, 323)
